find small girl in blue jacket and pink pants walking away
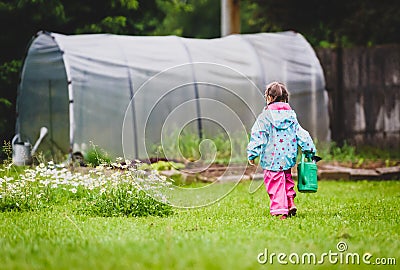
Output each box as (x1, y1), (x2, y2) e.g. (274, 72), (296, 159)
(247, 82), (316, 219)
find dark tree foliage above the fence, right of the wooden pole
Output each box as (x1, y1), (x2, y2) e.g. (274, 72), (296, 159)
(244, 0), (400, 46)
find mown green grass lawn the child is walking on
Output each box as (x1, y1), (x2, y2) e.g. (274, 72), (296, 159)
(0, 181), (400, 269)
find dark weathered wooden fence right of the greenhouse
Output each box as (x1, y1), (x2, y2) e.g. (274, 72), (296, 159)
(316, 44), (400, 151)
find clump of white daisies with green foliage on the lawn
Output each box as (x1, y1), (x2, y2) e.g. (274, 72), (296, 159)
(0, 162), (173, 216)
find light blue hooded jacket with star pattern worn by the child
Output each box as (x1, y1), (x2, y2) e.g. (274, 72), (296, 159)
(247, 102), (316, 171)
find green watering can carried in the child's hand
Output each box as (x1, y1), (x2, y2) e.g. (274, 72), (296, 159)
(297, 153), (321, 193)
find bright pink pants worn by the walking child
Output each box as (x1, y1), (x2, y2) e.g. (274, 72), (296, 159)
(264, 169), (296, 215)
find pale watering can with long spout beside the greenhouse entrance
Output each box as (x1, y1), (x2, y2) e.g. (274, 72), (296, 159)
(11, 127), (48, 166)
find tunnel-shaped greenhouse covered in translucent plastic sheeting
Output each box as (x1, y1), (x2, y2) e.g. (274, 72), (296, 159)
(16, 32), (329, 158)
